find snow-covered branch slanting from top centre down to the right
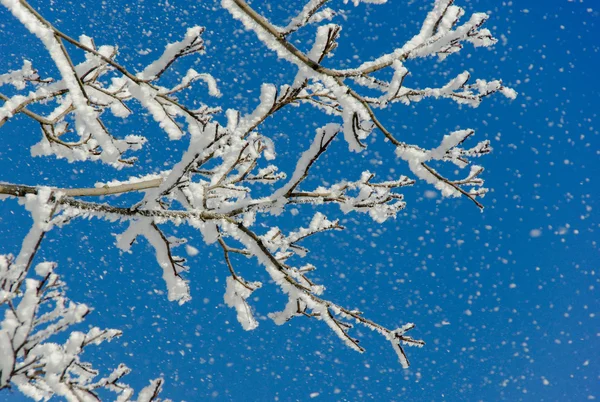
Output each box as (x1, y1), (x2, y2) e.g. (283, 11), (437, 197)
(222, 0), (516, 203)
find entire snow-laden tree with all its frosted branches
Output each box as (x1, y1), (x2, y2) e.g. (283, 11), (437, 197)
(0, 0), (516, 400)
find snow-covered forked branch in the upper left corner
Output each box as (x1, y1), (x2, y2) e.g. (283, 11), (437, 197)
(0, 0), (219, 168)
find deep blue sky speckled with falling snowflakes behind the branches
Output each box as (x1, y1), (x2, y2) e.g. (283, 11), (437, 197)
(0, 0), (600, 401)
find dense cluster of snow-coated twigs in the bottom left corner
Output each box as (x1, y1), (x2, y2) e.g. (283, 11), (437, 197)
(0, 255), (169, 402)
